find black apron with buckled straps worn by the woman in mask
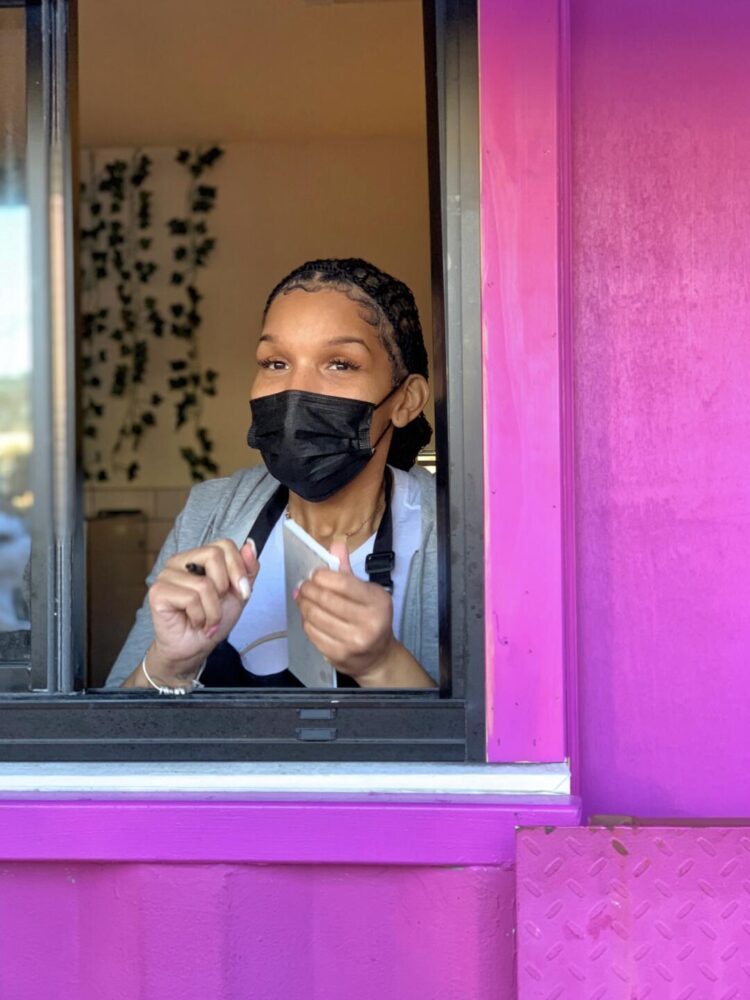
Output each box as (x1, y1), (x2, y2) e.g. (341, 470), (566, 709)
(201, 468), (396, 688)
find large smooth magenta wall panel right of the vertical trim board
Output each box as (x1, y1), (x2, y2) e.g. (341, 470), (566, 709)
(571, 0), (750, 816)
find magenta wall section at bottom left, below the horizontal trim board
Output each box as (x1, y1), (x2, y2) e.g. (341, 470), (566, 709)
(0, 863), (514, 1000)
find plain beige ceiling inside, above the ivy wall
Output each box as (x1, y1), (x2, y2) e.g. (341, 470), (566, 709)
(79, 0), (425, 146)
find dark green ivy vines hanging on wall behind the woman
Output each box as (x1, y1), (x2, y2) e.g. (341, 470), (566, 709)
(81, 146), (223, 482)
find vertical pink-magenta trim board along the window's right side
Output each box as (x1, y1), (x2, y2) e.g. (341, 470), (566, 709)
(479, 0), (572, 761)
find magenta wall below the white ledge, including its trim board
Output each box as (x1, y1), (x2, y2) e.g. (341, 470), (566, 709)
(0, 796), (579, 1000)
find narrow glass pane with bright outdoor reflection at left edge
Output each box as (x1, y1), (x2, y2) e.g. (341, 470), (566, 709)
(0, 7), (32, 667)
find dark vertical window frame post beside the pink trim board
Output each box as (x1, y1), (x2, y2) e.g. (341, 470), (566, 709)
(424, 0), (485, 760)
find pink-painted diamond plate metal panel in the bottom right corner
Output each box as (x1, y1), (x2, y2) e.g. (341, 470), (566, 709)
(516, 826), (750, 1000)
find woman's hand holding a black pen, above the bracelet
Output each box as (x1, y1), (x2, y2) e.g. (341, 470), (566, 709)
(147, 539), (259, 679)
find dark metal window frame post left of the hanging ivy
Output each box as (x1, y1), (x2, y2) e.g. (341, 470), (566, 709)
(27, 0), (83, 692)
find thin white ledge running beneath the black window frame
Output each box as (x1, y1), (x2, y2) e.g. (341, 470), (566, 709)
(0, 762), (570, 798)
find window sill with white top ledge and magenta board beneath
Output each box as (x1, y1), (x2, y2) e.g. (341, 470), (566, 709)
(0, 764), (581, 867)
